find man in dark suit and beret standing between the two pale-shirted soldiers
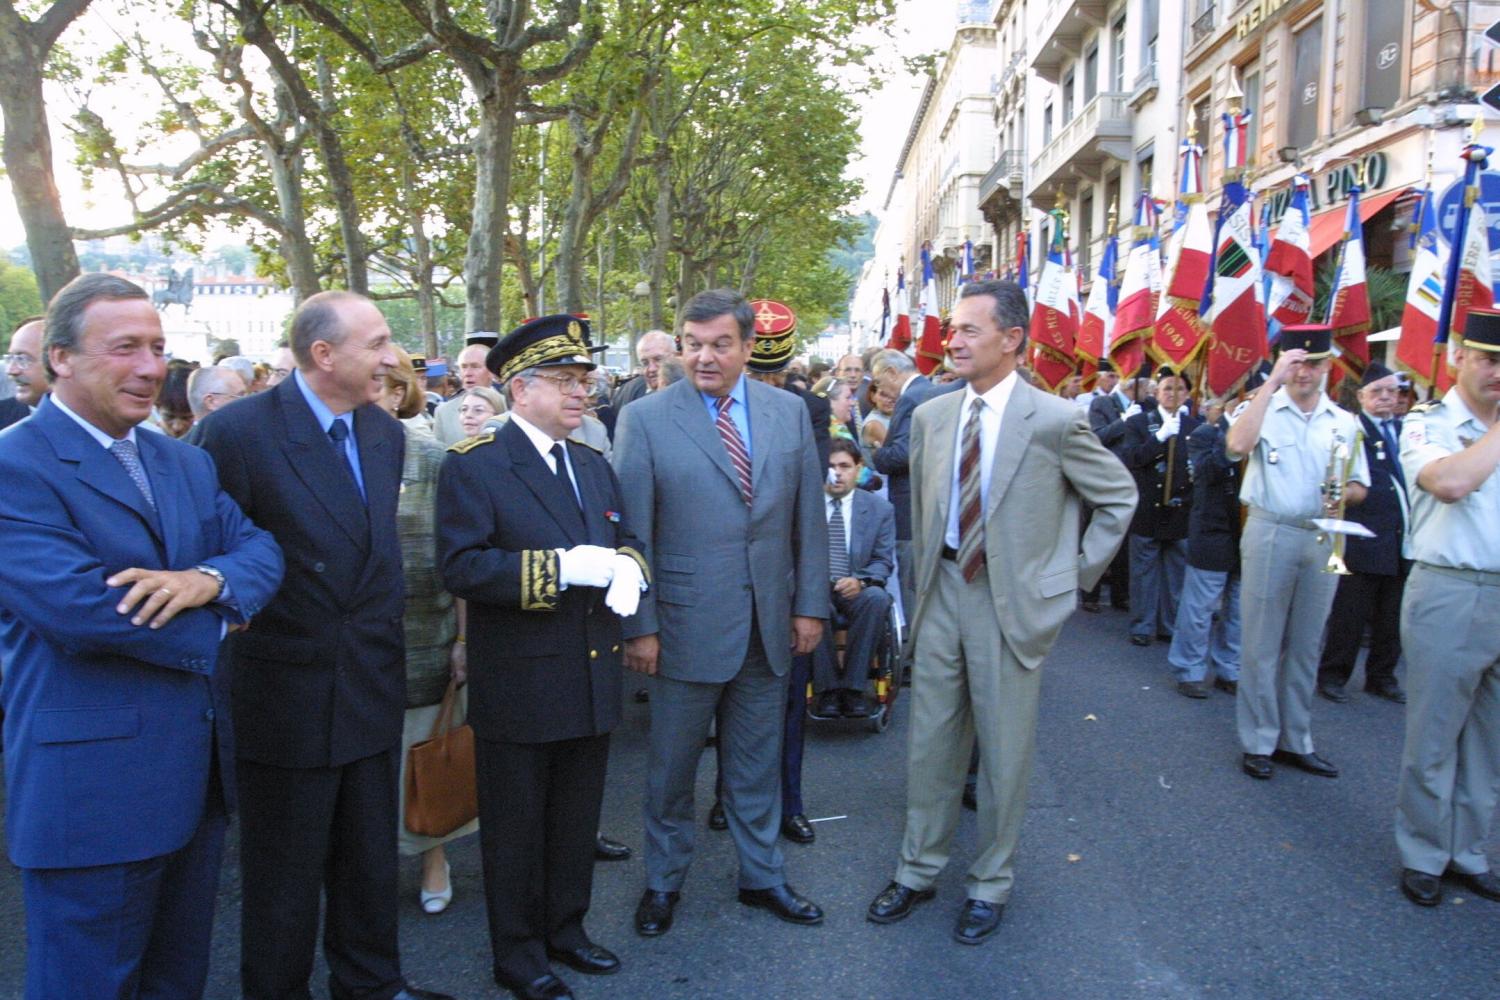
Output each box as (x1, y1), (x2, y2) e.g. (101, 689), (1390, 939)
(1317, 361), (1412, 705)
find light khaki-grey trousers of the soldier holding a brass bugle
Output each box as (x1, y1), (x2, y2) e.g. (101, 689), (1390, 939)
(1235, 510), (1338, 754)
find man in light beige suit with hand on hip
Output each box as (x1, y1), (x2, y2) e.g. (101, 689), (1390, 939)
(869, 282), (1136, 945)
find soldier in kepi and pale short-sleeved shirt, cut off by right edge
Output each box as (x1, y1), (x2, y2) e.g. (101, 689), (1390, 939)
(1397, 310), (1500, 906)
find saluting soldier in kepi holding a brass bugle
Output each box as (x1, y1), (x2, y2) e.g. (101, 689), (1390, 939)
(1224, 325), (1370, 778)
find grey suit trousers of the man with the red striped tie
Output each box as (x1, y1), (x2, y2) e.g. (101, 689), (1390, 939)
(645, 630), (786, 892)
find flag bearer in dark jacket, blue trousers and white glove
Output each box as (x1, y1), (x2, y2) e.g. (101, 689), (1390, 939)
(1119, 369), (1203, 646)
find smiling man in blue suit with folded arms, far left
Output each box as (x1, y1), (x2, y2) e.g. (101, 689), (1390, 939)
(0, 274), (282, 1000)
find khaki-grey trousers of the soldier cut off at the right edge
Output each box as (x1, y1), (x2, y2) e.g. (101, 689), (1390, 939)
(1397, 562), (1500, 876)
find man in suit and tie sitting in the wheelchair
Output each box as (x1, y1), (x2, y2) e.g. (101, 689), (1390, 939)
(813, 438), (896, 718)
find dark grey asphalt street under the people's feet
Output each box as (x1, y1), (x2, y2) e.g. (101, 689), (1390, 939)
(0, 612), (1500, 1000)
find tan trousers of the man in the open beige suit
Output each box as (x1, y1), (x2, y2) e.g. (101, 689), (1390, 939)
(896, 559), (1041, 903)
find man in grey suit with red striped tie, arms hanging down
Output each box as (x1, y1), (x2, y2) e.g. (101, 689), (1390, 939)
(615, 291), (828, 937)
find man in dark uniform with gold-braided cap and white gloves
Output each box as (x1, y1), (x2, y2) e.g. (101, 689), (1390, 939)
(437, 315), (647, 1000)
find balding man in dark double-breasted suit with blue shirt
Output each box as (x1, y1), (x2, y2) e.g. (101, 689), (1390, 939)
(203, 292), (450, 1000)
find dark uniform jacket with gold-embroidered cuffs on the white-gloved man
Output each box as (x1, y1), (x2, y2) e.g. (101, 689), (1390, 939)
(437, 421), (650, 744)
